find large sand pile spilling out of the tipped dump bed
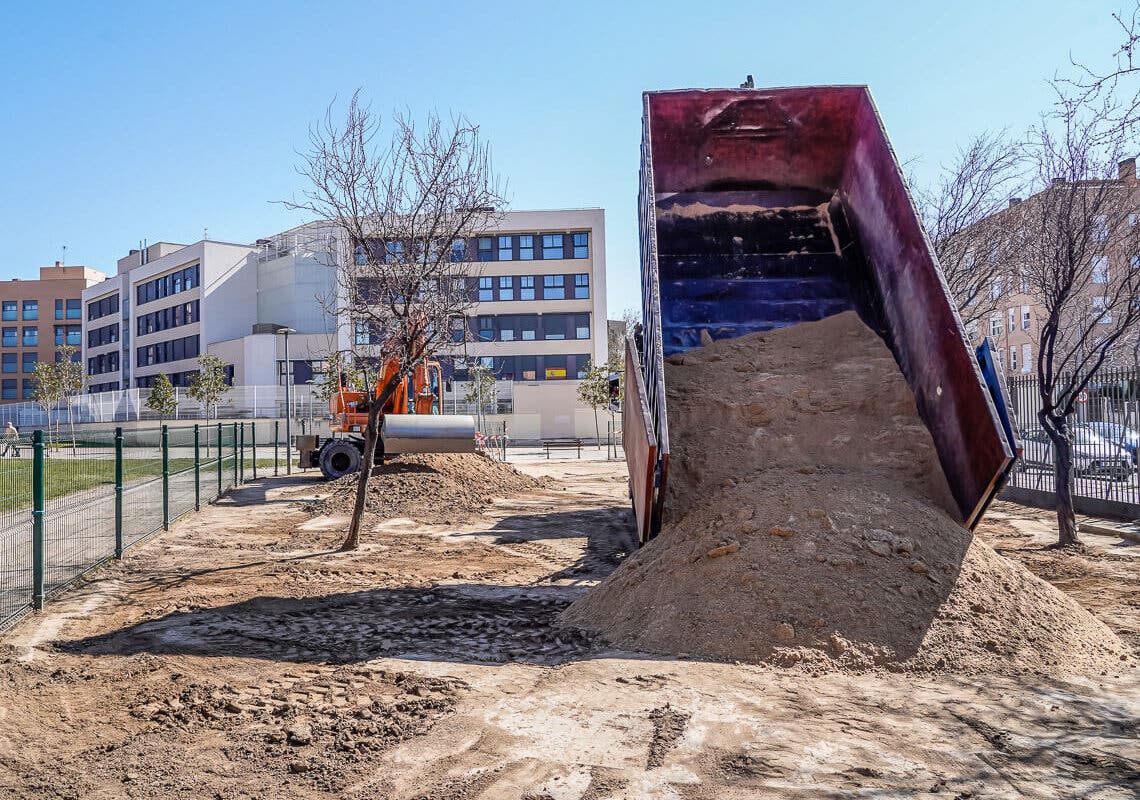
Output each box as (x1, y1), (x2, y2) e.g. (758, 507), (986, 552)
(564, 312), (1129, 672)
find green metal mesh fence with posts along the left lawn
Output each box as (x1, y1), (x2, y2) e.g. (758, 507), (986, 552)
(0, 419), (287, 628)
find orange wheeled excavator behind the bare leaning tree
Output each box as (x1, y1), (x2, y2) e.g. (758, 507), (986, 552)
(302, 359), (475, 479)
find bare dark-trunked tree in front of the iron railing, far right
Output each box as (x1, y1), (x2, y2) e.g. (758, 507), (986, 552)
(1009, 103), (1140, 545)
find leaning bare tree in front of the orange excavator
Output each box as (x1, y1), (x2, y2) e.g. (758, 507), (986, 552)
(287, 91), (503, 549)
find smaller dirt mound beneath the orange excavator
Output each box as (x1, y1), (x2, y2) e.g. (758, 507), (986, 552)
(307, 454), (546, 524)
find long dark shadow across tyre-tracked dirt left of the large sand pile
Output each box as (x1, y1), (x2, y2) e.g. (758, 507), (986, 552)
(55, 583), (596, 663)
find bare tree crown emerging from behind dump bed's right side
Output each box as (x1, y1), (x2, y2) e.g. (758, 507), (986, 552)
(912, 133), (1024, 327)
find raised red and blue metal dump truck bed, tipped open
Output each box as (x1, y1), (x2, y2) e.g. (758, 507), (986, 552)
(622, 87), (1016, 541)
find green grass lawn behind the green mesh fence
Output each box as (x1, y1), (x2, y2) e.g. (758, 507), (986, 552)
(0, 456), (284, 513)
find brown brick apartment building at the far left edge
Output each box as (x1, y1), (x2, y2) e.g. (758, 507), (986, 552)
(0, 261), (106, 402)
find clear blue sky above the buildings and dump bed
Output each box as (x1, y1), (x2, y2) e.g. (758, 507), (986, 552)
(0, 0), (1126, 316)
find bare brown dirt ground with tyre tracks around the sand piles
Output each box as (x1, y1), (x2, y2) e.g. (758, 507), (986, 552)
(0, 460), (1140, 800)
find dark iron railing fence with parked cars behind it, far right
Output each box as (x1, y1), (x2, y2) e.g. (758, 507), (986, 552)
(1007, 368), (1140, 519)
